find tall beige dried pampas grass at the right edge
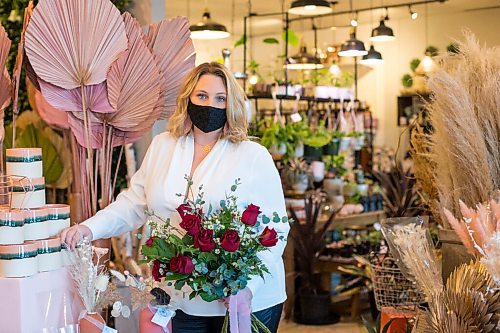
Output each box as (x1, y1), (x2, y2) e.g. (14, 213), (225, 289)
(414, 31), (500, 224)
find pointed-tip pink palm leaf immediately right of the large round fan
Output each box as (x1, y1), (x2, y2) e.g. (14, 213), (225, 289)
(102, 13), (162, 133)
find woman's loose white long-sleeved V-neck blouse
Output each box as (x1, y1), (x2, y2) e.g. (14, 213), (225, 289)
(83, 132), (290, 316)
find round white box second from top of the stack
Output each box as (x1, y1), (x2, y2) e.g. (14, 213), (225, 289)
(11, 177), (45, 209)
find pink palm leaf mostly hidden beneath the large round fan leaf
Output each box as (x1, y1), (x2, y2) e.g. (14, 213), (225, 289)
(38, 79), (115, 113)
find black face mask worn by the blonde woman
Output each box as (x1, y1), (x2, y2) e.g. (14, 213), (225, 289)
(187, 100), (227, 133)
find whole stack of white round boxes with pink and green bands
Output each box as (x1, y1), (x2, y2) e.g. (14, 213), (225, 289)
(0, 148), (70, 278)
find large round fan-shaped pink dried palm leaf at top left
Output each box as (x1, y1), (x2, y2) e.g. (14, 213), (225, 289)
(25, 0), (127, 89)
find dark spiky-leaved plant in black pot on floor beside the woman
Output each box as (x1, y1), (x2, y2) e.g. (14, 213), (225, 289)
(289, 191), (338, 324)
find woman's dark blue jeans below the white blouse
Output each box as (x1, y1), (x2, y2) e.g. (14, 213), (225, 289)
(172, 304), (283, 333)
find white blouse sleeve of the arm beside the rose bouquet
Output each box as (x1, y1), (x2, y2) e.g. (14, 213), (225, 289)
(247, 147), (290, 296)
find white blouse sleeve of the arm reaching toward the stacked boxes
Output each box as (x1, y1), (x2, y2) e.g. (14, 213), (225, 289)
(82, 137), (158, 240)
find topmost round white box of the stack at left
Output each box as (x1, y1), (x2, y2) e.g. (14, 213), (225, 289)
(5, 148), (43, 178)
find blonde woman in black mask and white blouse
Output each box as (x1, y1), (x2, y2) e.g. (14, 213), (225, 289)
(61, 63), (289, 333)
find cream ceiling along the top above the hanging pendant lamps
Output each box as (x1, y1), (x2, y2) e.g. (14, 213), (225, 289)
(165, 0), (500, 35)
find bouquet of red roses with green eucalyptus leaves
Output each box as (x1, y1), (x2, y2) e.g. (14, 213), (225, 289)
(142, 177), (292, 329)
